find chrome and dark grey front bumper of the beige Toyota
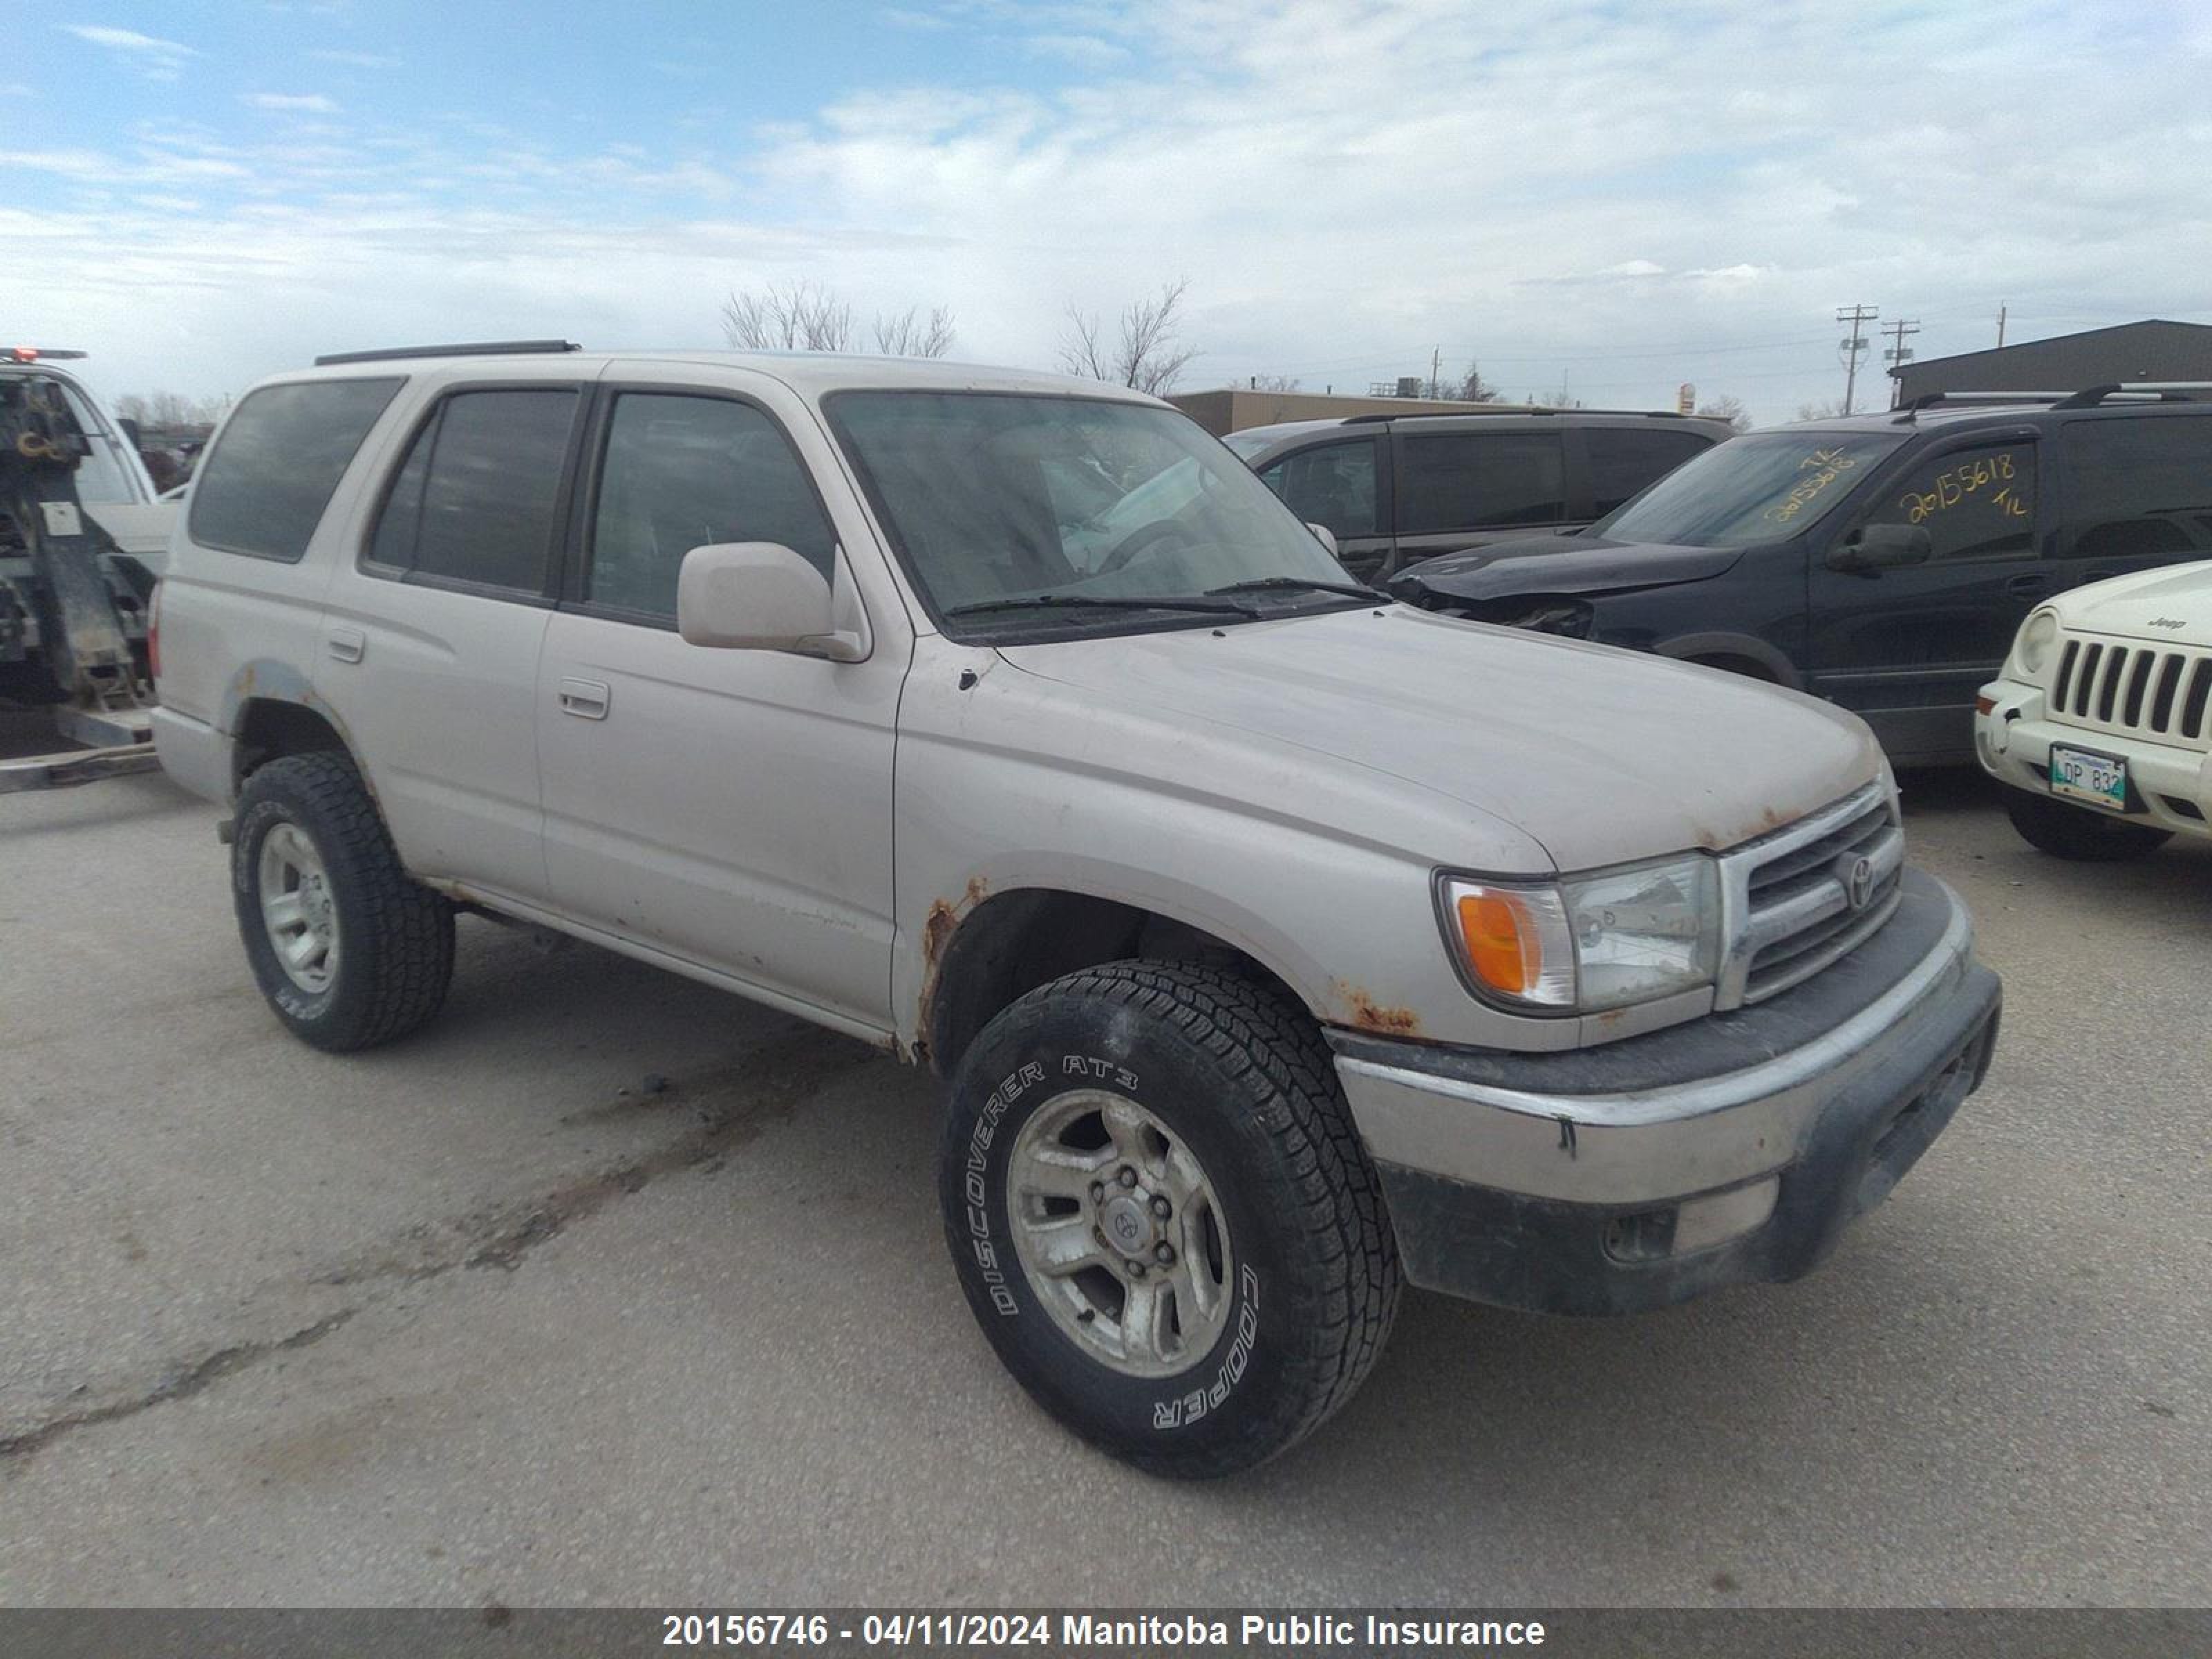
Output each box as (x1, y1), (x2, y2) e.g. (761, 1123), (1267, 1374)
(1331, 872), (2002, 1314)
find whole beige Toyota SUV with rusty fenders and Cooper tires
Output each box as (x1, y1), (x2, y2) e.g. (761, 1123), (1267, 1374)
(157, 343), (1998, 1475)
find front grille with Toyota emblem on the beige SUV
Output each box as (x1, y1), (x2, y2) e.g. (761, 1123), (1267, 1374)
(1714, 783), (1904, 1009)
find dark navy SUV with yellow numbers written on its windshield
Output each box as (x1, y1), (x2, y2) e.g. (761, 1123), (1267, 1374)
(1391, 385), (2212, 763)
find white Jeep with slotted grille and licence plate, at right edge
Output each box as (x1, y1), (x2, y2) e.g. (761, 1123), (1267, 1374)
(1973, 566), (2212, 861)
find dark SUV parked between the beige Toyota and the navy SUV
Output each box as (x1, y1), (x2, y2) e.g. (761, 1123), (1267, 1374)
(1221, 407), (1734, 582)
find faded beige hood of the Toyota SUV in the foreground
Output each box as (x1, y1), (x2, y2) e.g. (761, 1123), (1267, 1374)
(1000, 606), (1882, 874)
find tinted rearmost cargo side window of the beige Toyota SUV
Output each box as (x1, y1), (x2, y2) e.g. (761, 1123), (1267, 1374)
(188, 378), (400, 564)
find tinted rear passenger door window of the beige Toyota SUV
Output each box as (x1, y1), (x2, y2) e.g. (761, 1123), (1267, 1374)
(369, 387), (579, 593)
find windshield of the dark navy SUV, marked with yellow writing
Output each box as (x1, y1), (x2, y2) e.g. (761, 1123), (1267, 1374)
(1588, 431), (1906, 546)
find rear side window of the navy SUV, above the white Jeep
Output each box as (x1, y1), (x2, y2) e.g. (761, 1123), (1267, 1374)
(2064, 416), (2212, 560)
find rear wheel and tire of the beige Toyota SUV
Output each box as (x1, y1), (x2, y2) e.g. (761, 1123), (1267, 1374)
(230, 754), (453, 1051)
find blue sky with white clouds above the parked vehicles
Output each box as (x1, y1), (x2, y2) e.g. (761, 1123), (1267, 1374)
(0, 0), (2212, 420)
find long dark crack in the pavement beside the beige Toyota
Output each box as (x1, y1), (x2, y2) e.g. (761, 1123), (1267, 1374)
(0, 1029), (883, 1469)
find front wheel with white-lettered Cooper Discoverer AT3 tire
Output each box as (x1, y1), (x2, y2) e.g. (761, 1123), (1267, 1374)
(940, 962), (1400, 1478)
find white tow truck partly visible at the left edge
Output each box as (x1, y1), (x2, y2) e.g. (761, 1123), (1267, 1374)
(0, 345), (177, 794)
